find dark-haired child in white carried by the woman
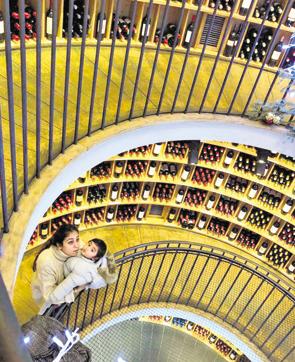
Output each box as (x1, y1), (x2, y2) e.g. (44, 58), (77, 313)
(50, 239), (117, 300)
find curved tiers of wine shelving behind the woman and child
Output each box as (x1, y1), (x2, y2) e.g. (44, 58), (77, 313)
(28, 141), (295, 278)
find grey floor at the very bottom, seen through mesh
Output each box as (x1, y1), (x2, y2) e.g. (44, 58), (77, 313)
(87, 320), (225, 362)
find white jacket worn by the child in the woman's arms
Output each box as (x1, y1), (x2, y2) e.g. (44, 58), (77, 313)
(50, 255), (107, 300)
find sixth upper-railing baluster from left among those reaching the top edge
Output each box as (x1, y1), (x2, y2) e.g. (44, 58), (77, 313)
(74, 0), (89, 144)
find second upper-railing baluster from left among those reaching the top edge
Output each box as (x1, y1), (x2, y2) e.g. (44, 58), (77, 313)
(18, 0), (29, 194)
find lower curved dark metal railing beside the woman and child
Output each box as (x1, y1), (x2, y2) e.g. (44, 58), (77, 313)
(62, 241), (295, 361)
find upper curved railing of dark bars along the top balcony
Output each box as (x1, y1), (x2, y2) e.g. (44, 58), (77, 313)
(0, 0), (292, 232)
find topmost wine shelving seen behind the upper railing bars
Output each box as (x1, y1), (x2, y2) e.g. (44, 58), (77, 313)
(0, 0), (295, 70)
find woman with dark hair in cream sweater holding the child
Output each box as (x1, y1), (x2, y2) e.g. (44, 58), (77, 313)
(32, 224), (80, 314)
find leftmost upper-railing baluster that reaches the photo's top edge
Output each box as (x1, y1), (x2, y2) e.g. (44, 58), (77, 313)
(4, 0), (18, 211)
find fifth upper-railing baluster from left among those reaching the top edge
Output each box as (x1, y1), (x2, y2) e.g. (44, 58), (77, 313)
(61, 0), (74, 153)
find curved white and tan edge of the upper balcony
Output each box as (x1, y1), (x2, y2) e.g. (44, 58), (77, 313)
(1, 114), (295, 292)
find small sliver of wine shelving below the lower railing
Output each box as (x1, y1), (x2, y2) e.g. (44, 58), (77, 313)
(139, 315), (245, 362)
